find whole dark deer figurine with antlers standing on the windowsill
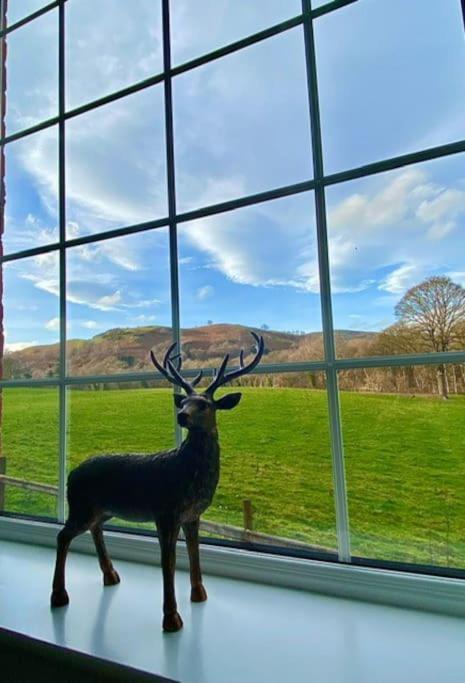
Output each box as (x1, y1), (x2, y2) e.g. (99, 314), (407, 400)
(51, 332), (264, 631)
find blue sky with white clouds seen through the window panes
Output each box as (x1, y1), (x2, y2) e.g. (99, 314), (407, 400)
(0, 0), (465, 358)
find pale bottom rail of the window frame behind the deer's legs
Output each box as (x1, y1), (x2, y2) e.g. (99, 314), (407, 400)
(0, 517), (465, 617)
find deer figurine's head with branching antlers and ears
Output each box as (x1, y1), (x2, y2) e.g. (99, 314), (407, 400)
(150, 332), (265, 432)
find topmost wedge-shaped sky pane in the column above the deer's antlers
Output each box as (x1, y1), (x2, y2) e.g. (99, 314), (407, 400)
(171, 0), (302, 64)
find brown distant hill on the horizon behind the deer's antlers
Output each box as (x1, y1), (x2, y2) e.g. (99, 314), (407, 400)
(4, 324), (375, 379)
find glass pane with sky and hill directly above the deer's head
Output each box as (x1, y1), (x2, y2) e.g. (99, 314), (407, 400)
(178, 193), (323, 367)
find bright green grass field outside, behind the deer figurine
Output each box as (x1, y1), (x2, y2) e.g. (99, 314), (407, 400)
(3, 388), (465, 567)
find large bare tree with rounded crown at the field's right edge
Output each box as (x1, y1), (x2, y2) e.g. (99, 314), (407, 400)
(395, 276), (465, 398)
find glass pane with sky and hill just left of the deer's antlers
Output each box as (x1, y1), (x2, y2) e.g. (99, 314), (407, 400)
(67, 228), (172, 375)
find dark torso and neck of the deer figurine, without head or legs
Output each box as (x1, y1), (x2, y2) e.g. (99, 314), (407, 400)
(68, 434), (220, 524)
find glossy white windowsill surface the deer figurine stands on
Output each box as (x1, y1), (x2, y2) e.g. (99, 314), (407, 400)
(0, 541), (464, 683)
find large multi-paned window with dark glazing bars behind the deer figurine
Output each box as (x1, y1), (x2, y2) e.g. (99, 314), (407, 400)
(0, 0), (465, 574)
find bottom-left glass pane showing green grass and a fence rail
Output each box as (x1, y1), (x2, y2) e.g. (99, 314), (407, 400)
(0, 388), (58, 519)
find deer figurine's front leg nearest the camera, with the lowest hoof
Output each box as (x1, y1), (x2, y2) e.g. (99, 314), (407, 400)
(156, 519), (182, 631)
